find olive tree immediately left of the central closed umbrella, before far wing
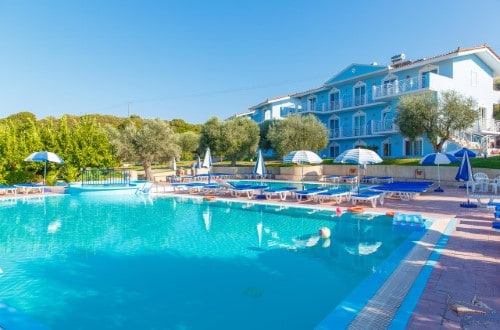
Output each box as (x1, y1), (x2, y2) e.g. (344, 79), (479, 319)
(222, 117), (259, 166)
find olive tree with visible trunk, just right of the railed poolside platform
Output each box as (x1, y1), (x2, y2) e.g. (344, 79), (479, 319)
(114, 119), (179, 181)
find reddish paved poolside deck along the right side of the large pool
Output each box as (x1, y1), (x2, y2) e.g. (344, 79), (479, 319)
(159, 184), (500, 329)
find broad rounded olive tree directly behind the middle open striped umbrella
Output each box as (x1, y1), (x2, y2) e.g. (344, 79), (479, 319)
(267, 114), (328, 157)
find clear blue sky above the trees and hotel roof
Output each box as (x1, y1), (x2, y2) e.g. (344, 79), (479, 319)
(0, 0), (500, 124)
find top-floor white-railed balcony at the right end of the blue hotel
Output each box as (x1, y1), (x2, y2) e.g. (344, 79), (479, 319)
(372, 72), (453, 101)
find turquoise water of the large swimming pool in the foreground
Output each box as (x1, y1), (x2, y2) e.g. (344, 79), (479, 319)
(0, 195), (426, 329)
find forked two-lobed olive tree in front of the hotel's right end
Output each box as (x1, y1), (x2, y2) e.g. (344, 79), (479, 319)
(395, 91), (478, 152)
